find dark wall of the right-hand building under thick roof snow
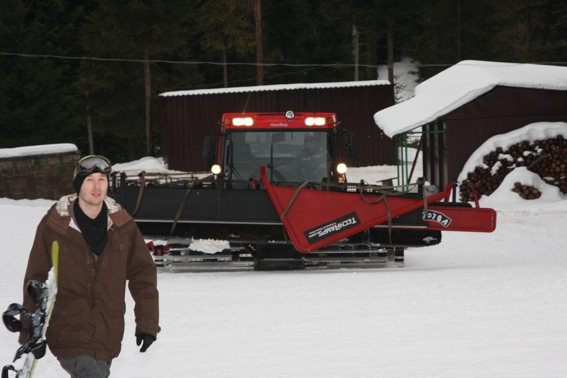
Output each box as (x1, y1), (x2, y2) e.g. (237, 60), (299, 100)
(424, 86), (567, 188)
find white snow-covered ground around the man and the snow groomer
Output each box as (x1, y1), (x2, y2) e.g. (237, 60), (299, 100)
(0, 159), (567, 378)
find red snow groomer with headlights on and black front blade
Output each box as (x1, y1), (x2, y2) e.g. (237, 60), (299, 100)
(109, 112), (496, 271)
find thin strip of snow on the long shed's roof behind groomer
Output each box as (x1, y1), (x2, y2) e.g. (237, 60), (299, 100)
(160, 80), (390, 97)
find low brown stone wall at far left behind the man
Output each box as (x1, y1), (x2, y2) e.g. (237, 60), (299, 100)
(0, 151), (80, 200)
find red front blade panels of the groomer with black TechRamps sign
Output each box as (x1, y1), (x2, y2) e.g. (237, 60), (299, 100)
(260, 167), (496, 253)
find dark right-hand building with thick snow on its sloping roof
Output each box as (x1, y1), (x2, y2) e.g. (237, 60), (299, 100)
(374, 61), (567, 192)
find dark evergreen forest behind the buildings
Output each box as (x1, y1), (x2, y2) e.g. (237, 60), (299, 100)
(0, 0), (567, 163)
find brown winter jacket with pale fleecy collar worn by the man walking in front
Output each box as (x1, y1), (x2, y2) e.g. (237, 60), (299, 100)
(20, 194), (160, 360)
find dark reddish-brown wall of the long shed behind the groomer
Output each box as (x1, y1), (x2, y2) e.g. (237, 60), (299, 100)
(159, 85), (395, 171)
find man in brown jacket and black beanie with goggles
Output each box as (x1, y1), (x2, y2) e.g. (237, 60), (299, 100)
(20, 155), (160, 378)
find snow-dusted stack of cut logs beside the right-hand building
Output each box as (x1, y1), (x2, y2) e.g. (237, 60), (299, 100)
(459, 135), (567, 202)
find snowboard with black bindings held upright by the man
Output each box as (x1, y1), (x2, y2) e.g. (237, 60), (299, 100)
(2, 241), (59, 378)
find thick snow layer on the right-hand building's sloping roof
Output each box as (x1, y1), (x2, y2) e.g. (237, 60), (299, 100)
(374, 60), (567, 137)
